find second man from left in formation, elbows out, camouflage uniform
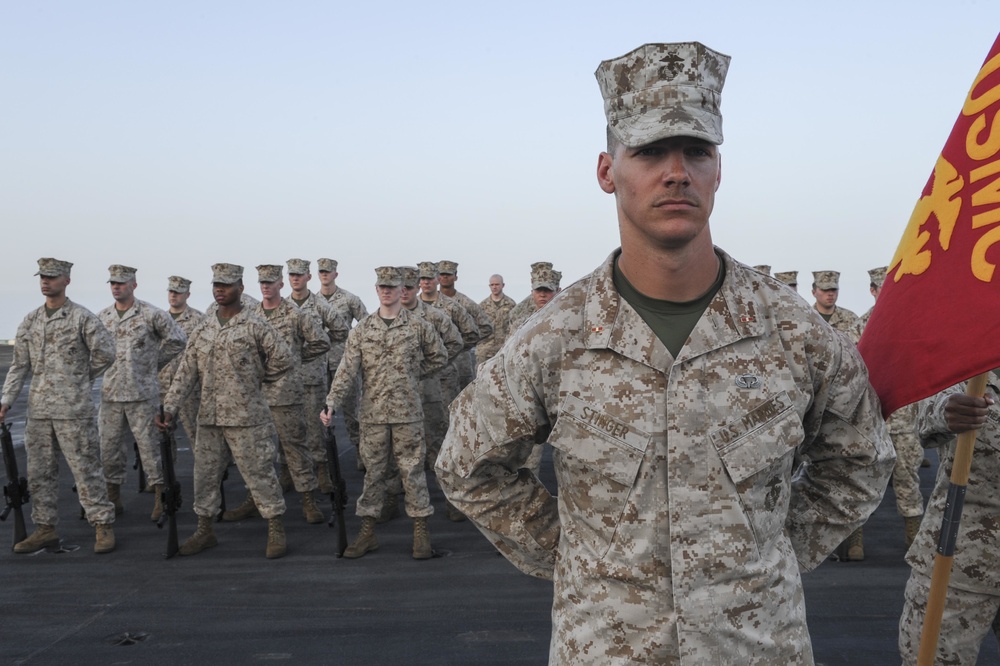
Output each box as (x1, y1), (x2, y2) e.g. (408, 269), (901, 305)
(97, 264), (187, 522)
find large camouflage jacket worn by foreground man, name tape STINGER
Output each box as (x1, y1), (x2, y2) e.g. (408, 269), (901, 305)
(437, 249), (895, 664)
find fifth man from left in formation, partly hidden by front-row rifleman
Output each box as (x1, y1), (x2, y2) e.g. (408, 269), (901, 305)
(222, 264), (330, 525)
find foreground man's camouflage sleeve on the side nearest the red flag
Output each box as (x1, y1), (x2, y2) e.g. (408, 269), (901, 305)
(785, 338), (896, 571)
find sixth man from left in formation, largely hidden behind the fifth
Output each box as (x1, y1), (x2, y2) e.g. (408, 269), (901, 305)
(282, 259), (351, 493)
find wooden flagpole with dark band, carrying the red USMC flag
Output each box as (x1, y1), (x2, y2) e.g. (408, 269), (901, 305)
(917, 372), (988, 666)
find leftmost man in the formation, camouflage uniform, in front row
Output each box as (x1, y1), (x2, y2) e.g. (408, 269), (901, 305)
(0, 257), (115, 554)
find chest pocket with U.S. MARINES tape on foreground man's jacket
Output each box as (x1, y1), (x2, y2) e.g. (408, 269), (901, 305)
(710, 392), (805, 549)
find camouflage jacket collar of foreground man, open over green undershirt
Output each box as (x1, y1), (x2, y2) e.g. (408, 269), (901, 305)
(583, 248), (763, 370)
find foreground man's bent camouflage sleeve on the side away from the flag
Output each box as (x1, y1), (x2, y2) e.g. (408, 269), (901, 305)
(436, 355), (560, 579)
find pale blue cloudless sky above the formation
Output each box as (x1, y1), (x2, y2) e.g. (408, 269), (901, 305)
(0, 0), (1000, 338)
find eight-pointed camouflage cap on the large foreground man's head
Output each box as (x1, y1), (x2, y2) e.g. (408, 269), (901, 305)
(594, 42), (730, 148)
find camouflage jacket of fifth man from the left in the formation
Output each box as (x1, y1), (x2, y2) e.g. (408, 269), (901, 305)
(251, 298), (330, 404)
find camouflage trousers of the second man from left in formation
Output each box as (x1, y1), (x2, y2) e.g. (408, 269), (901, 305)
(98, 400), (163, 486)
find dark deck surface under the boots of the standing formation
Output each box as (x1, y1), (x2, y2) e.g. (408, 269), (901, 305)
(0, 346), (1000, 666)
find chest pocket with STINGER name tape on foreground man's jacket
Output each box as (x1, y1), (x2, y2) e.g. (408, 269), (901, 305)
(549, 398), (650, 557)
